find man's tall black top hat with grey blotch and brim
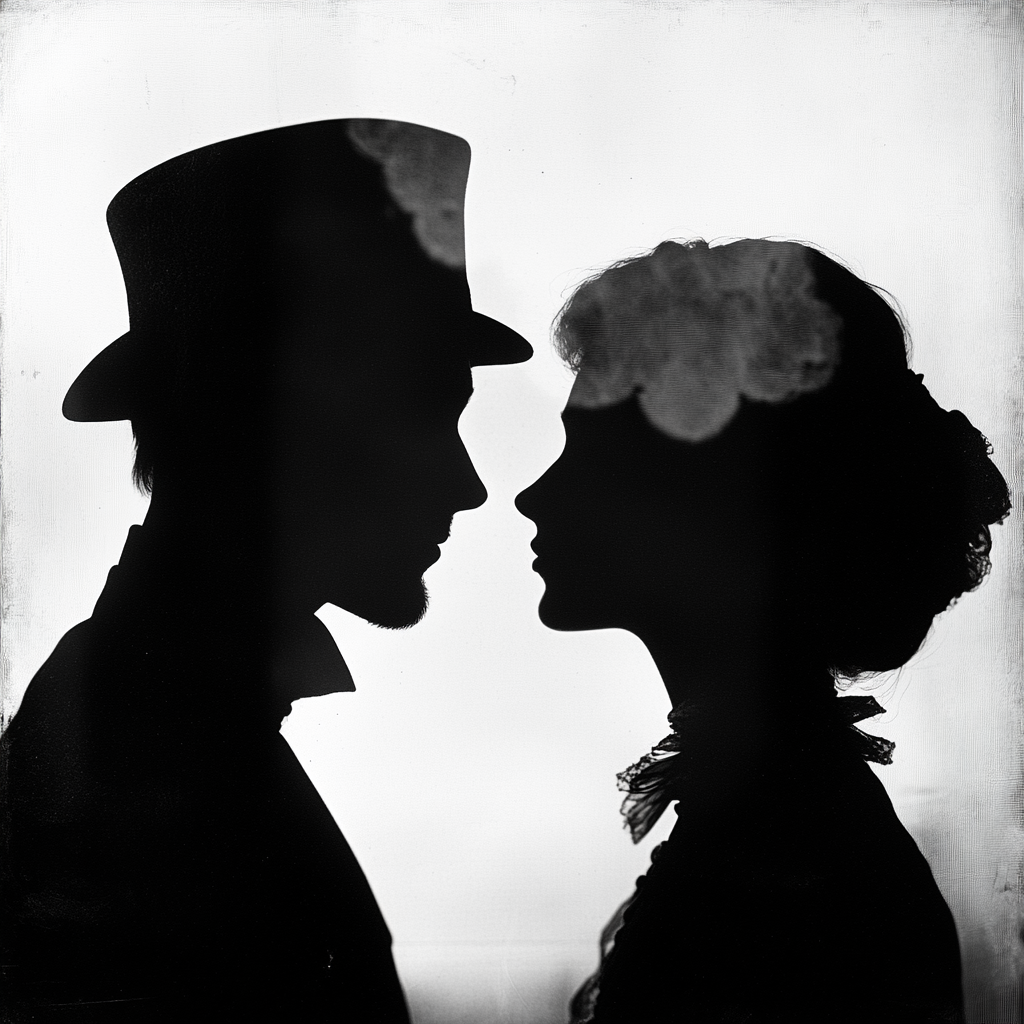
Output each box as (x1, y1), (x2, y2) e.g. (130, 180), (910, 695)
(63, 120), (532, 422)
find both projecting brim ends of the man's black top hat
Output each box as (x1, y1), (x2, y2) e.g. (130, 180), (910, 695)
(61, 310), (534, 423)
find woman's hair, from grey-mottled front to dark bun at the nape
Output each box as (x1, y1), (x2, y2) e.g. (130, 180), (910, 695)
(554, 242), (1010, 677)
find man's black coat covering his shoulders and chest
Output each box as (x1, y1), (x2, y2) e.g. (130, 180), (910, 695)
(3, 540), (408, 1024)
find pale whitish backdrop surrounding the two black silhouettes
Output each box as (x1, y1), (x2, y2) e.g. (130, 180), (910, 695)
(0, 0), (1024, 1024)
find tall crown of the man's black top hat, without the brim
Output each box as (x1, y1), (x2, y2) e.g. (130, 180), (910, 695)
(106, 120), (469, 329)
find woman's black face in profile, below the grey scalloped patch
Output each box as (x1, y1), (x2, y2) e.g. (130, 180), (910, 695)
(516, 395), (764, 637)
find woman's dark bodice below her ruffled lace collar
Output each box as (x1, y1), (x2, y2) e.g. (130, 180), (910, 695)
(592, 751), (964, 1024)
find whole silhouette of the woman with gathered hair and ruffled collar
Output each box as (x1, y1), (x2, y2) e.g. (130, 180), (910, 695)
(517, 235), (1010, 1024)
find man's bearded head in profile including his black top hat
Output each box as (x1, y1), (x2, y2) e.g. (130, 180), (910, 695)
(65, 120), (530, 628)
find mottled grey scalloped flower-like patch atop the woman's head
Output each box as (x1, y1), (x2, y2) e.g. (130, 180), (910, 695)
(555, 240), (842, 441)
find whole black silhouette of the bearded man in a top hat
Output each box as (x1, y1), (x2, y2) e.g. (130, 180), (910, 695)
(3, 121), (530, 1024)
